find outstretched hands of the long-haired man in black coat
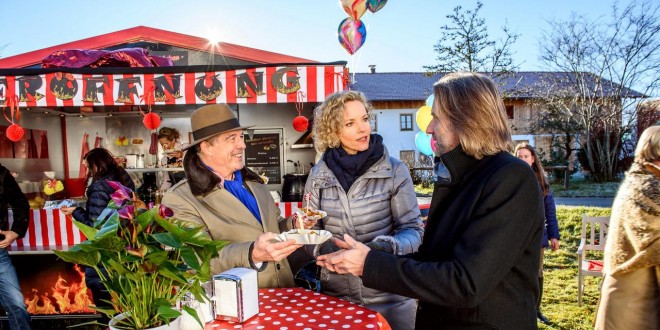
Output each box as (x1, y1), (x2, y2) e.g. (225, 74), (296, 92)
(316, 234), (371, 276)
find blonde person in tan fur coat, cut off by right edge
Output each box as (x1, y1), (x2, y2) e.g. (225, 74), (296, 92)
(596, 125), (660, 330)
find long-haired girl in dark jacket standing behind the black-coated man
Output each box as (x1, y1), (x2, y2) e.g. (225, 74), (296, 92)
(513, 142), (559, 324)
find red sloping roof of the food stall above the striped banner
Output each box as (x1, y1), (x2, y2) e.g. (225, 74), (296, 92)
(0, 26), (316, 68)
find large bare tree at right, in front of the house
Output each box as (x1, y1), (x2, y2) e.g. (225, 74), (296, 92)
(540, 0), (660, 181)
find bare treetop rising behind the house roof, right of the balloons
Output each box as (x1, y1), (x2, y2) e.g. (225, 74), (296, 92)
(424, 1), (519, 75)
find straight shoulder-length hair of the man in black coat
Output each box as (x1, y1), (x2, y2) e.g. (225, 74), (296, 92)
(433, 72), (513, 159)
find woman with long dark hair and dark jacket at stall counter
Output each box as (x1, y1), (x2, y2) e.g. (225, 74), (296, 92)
(61, 148), (135, 307)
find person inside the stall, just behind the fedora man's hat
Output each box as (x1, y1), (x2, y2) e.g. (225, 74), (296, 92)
(158, 127), (187, 190)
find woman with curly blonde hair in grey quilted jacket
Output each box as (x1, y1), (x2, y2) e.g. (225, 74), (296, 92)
(294, 91), (424, 330)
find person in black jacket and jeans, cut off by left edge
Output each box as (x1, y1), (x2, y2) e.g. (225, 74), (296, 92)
(0, 165), (31, 330)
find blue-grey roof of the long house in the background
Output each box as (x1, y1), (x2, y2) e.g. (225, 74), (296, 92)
(351, 72), (646, 101)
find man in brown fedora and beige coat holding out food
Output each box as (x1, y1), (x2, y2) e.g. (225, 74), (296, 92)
(162, 104), (301, 288)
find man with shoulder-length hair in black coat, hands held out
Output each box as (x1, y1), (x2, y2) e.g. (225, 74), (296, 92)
(317, 72), (543, 329)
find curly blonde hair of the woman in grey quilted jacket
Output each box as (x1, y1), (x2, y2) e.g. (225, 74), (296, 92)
(312, 91), (373, 152)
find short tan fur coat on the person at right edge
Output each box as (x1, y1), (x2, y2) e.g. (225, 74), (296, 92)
(604, 163), (660, 283)
